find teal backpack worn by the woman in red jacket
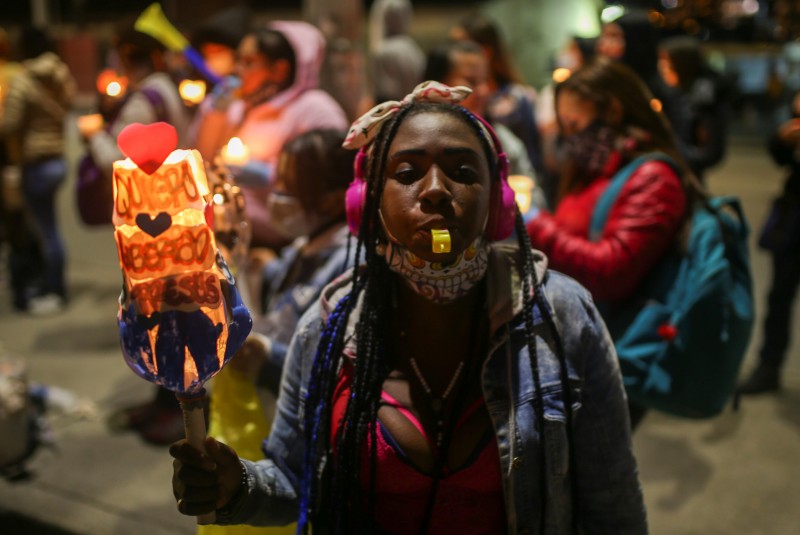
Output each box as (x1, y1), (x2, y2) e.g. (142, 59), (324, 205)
(590, 154), (753, 418)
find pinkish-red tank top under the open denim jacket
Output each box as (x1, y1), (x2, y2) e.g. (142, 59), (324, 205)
(331, 363), (507, 534)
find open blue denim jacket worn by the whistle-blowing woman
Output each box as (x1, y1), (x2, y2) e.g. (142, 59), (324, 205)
(217, 245), (647, 535)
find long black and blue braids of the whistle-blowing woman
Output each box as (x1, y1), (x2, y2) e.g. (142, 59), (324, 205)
(299, 102), (564, 533)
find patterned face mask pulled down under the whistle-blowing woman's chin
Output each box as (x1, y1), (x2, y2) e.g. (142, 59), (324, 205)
(379, 235), (489, 304)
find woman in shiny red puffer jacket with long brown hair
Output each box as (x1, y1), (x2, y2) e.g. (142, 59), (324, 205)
(527, 58), (695, 430)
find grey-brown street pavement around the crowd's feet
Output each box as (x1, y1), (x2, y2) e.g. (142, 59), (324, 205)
(0, 119), (800, 535)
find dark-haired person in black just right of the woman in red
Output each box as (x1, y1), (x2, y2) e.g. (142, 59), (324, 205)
(658, 36), (731, 180)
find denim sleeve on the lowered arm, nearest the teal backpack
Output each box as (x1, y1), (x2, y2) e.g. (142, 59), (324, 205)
(553, 276), (647, 535)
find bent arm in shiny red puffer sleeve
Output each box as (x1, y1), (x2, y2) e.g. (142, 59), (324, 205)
(527, 161), (686, 301)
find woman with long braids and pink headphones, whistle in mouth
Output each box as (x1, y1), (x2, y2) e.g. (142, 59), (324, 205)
(170, 82), (647, 534)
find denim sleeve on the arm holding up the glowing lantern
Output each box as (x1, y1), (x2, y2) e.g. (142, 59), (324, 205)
(217, 305), (322, 526)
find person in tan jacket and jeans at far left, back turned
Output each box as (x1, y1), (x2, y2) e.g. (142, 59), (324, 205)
(0, 27), (77, 314)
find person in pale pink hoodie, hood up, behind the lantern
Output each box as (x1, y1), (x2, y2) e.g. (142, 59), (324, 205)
(196, 21), (348, 250)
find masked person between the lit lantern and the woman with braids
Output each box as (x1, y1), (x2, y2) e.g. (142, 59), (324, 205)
(200, 129), (354, 535)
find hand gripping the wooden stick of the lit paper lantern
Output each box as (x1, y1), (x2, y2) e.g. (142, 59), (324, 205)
(169, 437), (244, 516)
